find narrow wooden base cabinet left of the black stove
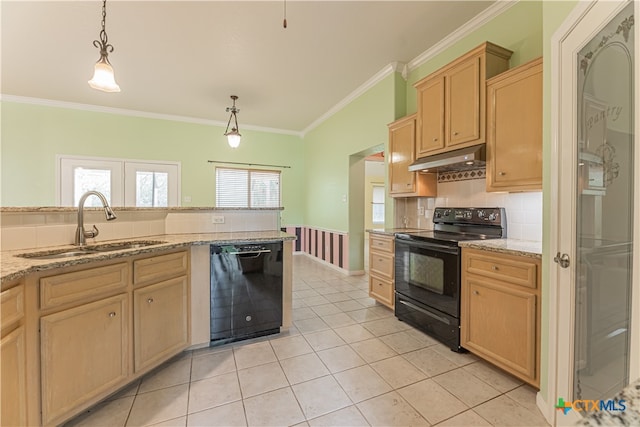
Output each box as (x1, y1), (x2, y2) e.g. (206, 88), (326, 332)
(369, 233), (395, 309)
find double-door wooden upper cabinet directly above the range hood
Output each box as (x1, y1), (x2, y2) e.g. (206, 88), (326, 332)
(414, 42), (512, 158)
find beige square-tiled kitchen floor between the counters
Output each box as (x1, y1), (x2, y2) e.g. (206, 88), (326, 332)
(67, 255), (547, 426)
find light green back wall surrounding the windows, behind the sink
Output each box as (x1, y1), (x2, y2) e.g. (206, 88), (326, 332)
(1, 102), (305, 224)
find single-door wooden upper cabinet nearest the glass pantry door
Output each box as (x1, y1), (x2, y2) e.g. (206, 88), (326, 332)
(487, 58), (542, 191)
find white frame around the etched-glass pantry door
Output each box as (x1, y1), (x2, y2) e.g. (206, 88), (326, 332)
(543, 0), (640, 425)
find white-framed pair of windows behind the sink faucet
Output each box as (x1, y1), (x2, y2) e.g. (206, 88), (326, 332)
(57, 156), (180, 207)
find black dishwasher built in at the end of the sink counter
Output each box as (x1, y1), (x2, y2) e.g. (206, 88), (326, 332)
(211, 242), (282, 345)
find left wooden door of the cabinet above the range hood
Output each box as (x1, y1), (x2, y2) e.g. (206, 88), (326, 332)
(416, 76), (445, 158)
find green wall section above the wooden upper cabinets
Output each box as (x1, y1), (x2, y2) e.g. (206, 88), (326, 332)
(407, 1), (546, 114)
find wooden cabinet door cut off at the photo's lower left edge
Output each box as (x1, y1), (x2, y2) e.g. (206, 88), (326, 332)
(0, 326), (27, 426)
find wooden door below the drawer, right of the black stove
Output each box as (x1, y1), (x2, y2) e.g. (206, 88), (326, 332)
(461, 277), (536, 382)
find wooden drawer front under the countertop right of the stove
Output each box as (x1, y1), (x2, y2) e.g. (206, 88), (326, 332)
(464, 251), (538, 289)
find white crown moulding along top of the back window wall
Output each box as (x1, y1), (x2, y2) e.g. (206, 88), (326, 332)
(0, 94), (304, 138)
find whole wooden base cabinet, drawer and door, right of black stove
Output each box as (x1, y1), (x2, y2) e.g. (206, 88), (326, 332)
(460, 248), (541, 387)
